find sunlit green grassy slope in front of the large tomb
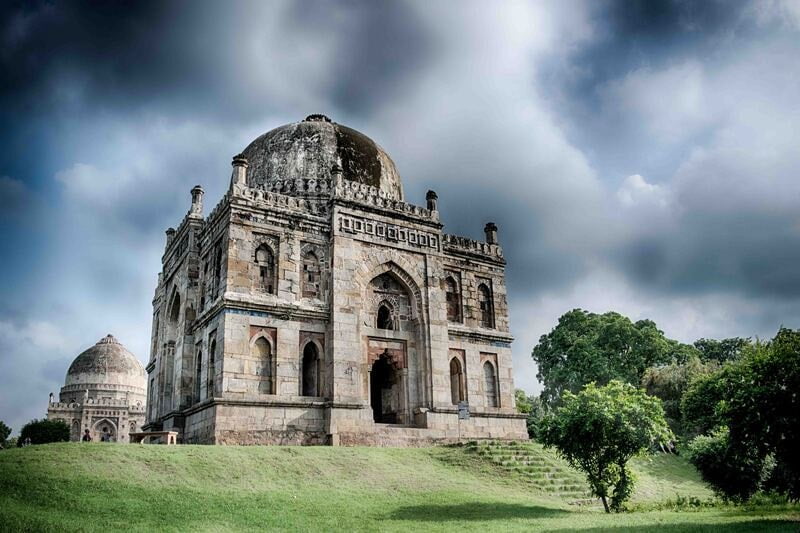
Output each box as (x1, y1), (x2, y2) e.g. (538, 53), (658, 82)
(0, 443), (800, 533)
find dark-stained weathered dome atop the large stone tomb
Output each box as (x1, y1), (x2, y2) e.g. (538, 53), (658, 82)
(242, 115), (403, 200)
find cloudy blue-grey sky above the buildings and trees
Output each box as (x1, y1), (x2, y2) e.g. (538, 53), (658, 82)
(0, 0), (800, 430)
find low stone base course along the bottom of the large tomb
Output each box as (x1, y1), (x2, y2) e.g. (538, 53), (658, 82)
(162, 401), (528, 447)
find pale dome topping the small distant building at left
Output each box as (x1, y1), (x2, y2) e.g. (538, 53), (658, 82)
(64, 335), (146, 390)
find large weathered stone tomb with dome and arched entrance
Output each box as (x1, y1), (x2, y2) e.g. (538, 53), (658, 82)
(145, 115), (527, 445)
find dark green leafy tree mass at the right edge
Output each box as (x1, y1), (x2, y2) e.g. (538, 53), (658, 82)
(682, 328), (800, 500)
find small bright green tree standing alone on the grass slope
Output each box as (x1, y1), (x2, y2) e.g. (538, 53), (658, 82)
(542, 380), (672, 512)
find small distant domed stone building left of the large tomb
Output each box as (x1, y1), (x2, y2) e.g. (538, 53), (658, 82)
(47, 334), (147, 442)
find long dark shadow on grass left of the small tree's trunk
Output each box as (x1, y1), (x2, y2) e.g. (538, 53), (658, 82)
(388, 502), (569, 522)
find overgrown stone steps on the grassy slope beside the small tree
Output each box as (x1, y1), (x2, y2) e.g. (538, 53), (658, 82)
(465, 441), (597, 505)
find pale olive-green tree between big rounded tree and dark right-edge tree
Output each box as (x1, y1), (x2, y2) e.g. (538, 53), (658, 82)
(642, 354), (719, 436)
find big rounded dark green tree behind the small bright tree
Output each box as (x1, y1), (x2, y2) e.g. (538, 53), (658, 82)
(531, 309), (696, 407)
